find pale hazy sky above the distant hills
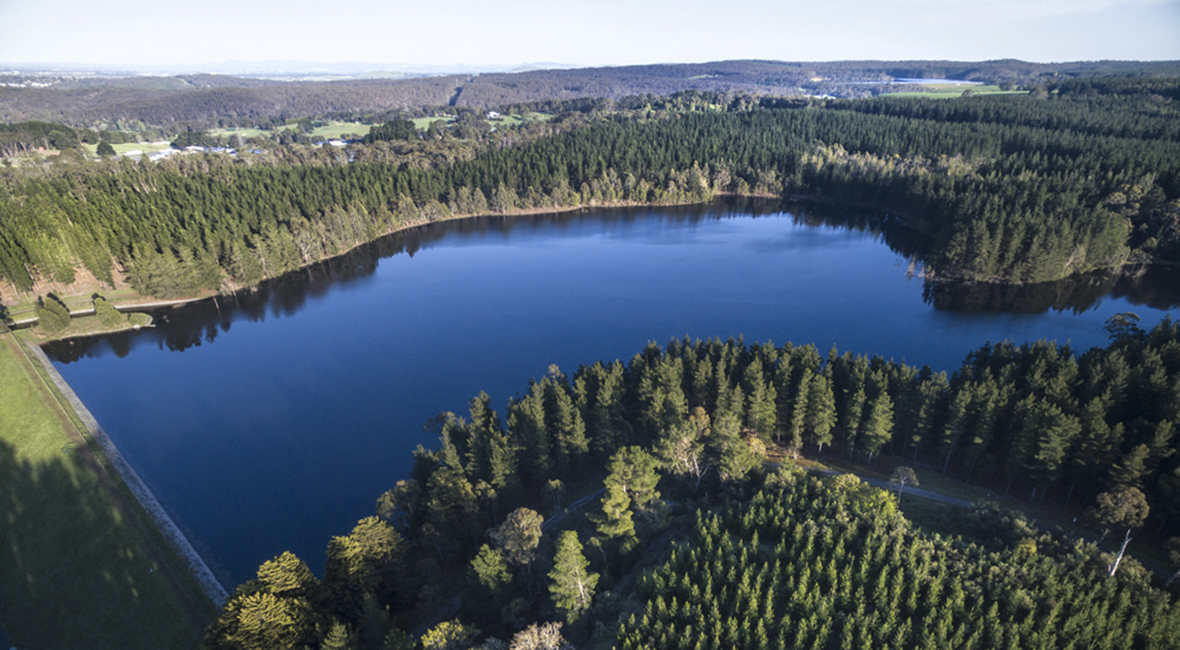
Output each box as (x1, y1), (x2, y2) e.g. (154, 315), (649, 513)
(0, 0), (1180, 65)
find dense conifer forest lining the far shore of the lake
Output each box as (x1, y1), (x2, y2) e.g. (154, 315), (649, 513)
(0, 81), (1180, 297)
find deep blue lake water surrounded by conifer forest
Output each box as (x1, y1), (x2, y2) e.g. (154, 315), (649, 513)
(47, 200), (1180, 583)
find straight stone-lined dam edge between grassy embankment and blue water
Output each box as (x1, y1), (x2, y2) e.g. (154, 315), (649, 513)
(18, 342), (229, 609)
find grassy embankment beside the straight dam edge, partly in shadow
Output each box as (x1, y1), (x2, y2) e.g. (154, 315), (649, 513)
(0, 333), (216, 650)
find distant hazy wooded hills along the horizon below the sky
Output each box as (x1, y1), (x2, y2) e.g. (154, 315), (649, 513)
(0, 59), (1180, 127)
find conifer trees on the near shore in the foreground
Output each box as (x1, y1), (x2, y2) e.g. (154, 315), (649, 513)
(205, 316), (1180, 649)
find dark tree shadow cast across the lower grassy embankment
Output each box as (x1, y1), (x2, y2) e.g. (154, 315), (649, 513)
(0, 441), (199, 649)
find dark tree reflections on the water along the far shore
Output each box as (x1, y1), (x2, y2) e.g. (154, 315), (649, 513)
(45, 198), (1180, 363)
